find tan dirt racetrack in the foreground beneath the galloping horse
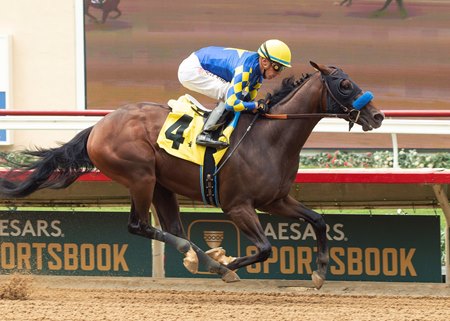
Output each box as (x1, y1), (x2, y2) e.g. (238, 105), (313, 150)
(0, 276), (450, 321)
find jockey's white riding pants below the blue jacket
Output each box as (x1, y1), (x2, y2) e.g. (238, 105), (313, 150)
(178, 53), (231, 101)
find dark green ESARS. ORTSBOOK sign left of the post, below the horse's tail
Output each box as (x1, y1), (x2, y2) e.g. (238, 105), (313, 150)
(0, 211), (152, 276)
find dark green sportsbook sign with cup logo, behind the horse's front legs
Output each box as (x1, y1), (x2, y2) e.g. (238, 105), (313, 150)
(166, 213), (441, 282)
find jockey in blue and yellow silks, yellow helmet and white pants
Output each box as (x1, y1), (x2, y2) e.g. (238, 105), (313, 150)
(178, 39), (291, 149)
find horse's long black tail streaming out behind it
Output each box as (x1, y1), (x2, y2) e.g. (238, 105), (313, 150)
(0, 127), (95, 197)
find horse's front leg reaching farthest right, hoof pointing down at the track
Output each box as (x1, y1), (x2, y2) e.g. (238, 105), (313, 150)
(261, 196), (330, 289)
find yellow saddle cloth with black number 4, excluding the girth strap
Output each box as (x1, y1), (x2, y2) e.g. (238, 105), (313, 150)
(157, 94), (240, 165)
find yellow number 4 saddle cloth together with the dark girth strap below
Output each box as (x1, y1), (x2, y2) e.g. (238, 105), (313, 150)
(157, 94), (240, 206)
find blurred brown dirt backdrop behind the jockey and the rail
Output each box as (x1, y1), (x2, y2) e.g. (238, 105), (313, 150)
(86, 0), (450, 149)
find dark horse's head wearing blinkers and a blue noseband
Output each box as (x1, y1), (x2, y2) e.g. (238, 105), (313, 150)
(310, 61), (384, 131)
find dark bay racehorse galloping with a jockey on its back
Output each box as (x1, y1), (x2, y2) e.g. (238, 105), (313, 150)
(0, 62), (384, 289)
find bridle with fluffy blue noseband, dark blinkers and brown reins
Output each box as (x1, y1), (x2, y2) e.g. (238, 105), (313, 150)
(263, 66), (373, 129)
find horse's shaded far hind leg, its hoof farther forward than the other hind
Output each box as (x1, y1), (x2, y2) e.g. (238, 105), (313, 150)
(153, 183), (239, 282)
